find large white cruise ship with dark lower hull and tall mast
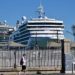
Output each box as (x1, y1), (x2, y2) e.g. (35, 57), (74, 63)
(10, 4), (64, 48)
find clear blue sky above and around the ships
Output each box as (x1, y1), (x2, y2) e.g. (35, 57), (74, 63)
(0, 0), (75, 39)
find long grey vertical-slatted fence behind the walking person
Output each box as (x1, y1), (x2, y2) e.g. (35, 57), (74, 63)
(0, 49), (61, 69)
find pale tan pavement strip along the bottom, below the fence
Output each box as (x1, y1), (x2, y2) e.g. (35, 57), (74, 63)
(0, 71), (59, 75)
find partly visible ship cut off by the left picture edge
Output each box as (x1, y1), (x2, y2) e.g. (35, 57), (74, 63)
(0, 20), (14, 44)
